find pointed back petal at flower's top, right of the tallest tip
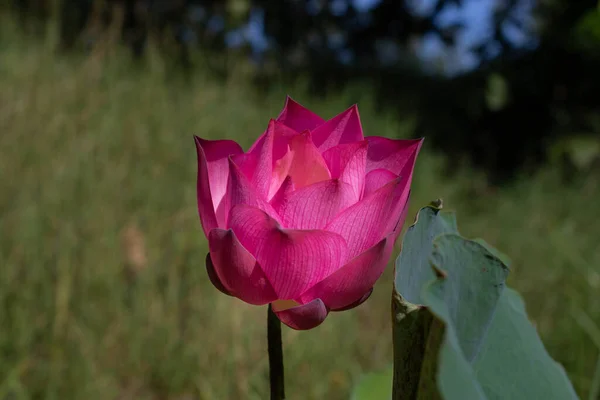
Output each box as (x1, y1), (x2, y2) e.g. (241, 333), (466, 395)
(312, 105), (364, 153)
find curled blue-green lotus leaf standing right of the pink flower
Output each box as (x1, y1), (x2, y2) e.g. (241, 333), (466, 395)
(386, 205), (577, 400)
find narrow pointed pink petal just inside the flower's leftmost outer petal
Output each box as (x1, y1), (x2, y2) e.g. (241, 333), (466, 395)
(217, 158), (280, 226)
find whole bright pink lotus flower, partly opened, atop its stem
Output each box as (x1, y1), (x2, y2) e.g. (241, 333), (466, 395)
(195, 97), (422, 329)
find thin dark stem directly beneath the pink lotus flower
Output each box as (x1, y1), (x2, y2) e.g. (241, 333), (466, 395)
(267, 304), (285, 400)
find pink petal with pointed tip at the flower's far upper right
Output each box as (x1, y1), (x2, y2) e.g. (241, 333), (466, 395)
(367, 136), (423, 175)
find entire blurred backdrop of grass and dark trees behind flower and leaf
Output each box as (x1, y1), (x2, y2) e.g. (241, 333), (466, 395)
(0, 0), (600, 400)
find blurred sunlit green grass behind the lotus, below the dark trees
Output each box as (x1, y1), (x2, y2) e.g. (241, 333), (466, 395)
(0, 18), (600, 400)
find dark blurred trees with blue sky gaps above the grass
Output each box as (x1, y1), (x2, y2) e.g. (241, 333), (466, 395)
(7, 0), (600, 182)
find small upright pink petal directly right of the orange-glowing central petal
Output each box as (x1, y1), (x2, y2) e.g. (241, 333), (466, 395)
(323, 140), (368, 202)
